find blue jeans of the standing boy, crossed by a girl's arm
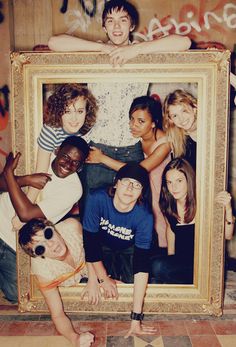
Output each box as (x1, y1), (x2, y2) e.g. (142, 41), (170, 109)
(83, 141), (144, 190)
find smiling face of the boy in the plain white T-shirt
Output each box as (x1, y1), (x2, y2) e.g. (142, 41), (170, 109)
(52, 145), (84, 178)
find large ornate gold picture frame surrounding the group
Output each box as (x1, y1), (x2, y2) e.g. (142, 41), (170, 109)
(11, 51), (230, 316)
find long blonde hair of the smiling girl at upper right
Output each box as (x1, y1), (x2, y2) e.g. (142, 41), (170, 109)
(163, 89), (197, 158)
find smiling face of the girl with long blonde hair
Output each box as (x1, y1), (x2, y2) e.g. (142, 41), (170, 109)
(169, 104), (196, 133)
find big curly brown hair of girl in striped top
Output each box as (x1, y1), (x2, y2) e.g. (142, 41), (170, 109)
(43, 83), (98, 135)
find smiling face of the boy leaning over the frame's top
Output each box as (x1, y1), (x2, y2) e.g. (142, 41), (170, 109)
(104, 10), (134, 46)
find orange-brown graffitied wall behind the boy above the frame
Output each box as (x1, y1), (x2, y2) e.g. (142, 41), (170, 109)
(13, 0), (236, 50)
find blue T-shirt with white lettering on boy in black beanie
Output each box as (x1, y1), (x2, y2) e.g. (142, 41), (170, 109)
(83, 189), (153, 250)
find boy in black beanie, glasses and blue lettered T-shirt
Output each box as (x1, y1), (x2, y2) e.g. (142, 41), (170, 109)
(83, 163), (155, 337)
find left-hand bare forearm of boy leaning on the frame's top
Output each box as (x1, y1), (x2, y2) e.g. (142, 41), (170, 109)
(48, 34), (113, 53)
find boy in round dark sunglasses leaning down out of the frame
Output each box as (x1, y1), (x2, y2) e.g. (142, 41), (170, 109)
(19, 218), (94, 347)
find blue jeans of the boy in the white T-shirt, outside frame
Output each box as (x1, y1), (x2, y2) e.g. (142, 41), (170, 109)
(0, 239), (18, 303)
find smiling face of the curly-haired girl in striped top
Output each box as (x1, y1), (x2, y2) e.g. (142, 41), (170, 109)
(62, 96), (86, 134)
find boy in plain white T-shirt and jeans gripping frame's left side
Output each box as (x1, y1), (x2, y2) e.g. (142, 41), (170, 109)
(0, 136), (89, 302)
